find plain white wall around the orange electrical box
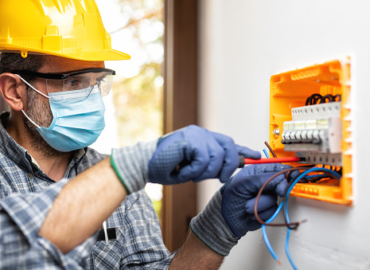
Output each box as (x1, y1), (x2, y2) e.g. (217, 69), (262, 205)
(198, 0), (370, 270)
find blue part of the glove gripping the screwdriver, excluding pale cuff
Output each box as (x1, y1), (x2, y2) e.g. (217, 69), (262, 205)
(149, 125), (261, 185)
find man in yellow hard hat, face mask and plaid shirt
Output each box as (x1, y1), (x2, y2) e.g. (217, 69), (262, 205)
(0, 0), (286, 269)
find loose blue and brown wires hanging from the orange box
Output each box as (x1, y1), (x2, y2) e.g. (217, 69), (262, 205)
(254, 142), (341, 270)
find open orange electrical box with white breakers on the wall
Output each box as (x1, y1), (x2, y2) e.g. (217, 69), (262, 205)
(269, 58), (353, 205)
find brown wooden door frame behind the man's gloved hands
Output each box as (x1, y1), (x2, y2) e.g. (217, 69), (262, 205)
(162, 0), (198, 252)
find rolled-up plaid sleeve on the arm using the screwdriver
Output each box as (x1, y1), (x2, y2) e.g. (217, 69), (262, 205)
(0, 180), (94, 269)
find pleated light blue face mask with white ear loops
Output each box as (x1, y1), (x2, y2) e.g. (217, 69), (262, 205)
(20, 77), (105, 152)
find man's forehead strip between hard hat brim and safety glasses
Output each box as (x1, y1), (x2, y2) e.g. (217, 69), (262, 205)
(38, 55), (105, 73)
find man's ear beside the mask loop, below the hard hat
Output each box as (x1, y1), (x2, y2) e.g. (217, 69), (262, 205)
(0, 73), (27, 111)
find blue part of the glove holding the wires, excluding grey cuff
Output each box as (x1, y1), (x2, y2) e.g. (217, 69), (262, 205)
(221, 164), (294, 237)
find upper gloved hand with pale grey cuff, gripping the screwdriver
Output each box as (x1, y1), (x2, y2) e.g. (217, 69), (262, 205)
(111, 125), (261, 194)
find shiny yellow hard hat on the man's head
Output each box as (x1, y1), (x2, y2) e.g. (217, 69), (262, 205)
(0, 0), (131, 61)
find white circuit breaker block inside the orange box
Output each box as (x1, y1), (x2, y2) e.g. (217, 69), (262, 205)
(281, 102), (342, 166)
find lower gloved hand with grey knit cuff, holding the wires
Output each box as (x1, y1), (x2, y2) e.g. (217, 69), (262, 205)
(190, 164), (291, 256)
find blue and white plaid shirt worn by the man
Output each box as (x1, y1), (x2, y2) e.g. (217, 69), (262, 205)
(0, 113), (175, 269)
